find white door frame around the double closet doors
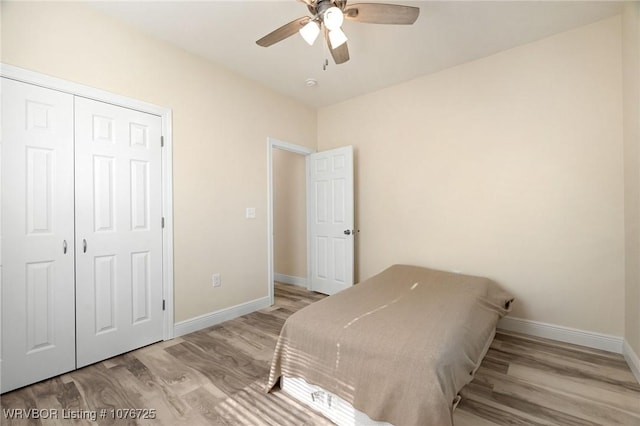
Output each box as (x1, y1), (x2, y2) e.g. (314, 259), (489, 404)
(0, 63), (174, 340)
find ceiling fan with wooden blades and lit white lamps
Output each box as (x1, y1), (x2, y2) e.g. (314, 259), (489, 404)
(256, 0), (420, 64)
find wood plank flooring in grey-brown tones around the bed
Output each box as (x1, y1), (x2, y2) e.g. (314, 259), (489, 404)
(0, 284), (640, 426)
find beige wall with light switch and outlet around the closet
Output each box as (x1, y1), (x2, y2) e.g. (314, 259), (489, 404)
(2, 2), (316, 321)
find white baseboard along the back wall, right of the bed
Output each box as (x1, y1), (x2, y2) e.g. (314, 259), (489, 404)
(498, 317), (623, 354)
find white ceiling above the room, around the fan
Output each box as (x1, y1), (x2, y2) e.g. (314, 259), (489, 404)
(91, 0), (622, 107)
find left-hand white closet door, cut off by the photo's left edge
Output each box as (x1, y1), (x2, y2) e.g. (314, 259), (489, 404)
(1, 78), (75, 392)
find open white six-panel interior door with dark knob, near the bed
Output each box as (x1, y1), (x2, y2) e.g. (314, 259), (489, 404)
(307, 146), (354, 294)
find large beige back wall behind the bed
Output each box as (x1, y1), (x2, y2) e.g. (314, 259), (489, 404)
(318, 17), (625, 336)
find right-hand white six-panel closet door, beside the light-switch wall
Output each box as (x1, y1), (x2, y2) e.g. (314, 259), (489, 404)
(75, 98), (163, 368)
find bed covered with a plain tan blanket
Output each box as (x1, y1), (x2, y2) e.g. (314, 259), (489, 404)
(267, 265), (513, 426)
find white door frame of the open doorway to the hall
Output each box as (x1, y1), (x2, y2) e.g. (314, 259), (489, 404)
(267, 137), (316, 305)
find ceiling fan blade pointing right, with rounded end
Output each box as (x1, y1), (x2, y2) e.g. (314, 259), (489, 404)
(344, 3), (420, 25)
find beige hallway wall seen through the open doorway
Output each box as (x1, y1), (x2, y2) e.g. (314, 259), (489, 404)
(273, 149), (307, 279)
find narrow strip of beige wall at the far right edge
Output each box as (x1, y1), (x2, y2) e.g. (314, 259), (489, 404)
(622, 2), (640, 354)
